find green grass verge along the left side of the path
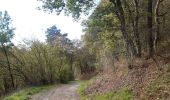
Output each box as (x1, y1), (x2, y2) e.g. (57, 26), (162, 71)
(2, 85), (56, 100)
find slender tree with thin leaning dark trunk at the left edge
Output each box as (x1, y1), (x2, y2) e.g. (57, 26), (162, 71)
(0, 11), (15, 88)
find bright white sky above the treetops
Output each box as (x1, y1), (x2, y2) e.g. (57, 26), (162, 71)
(0, 0), (83, 44)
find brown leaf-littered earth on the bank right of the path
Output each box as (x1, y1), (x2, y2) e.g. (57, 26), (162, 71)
(84, 56), (170, 100)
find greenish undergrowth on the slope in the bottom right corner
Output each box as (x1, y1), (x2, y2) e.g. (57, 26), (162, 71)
(144, 64), (170, 100)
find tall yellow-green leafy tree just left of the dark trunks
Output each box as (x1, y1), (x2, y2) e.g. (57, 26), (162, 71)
(82, 0), (124, 70)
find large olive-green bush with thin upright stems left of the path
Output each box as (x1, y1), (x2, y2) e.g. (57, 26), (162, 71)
(12, 41), (74, 84)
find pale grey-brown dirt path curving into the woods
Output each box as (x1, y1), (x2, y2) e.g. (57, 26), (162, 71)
(31, 83), (80, 100)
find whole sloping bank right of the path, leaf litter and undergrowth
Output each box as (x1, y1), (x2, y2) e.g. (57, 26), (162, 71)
(80, 56), (170, 100)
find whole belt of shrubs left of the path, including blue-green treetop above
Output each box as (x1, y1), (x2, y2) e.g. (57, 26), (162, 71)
(0, 22), (95, 96)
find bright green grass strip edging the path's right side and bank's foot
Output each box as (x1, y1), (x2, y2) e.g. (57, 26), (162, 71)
(78, 81), (133, 100)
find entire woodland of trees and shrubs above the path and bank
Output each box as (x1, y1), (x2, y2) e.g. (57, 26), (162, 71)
(0, 0), (170, 96)
